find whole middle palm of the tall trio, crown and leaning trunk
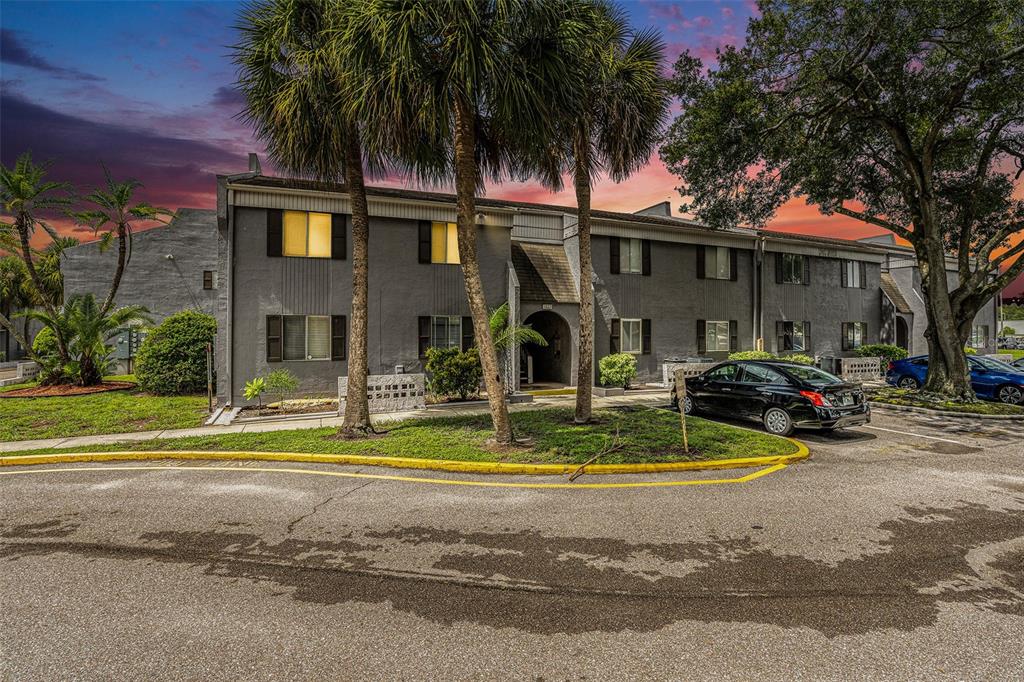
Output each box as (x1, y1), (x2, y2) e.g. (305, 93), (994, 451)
(340, 0), (589, 443)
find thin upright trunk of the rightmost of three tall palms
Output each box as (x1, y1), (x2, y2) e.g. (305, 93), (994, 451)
(573, 140), (594, 424)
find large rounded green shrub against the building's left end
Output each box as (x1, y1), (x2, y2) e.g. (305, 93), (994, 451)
(135, 310), (217, 395)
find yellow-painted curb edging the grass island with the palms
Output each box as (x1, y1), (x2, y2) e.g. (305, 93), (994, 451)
(0, 438), (810, 476)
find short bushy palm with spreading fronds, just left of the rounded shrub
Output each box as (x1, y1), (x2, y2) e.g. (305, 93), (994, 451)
(19, 294), (153, 386)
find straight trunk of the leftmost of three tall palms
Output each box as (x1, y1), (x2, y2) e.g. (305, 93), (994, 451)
(341, 129), (370, 435)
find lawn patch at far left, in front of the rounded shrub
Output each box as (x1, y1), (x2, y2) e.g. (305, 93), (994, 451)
(0, 377), (208, 441)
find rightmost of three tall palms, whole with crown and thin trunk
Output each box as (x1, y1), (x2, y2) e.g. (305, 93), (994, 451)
(540, 1), (670, 424)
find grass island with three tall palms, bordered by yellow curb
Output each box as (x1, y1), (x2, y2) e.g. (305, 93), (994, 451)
(0, 408), (797, 464)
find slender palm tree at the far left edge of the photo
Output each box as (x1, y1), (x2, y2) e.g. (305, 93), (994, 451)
(0, 153), (71, 359)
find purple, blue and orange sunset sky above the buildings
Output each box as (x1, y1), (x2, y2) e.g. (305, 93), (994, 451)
(0, 0), (1022, 290)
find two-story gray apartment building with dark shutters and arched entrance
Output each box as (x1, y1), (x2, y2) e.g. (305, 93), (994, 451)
(211, 164), (995, 402)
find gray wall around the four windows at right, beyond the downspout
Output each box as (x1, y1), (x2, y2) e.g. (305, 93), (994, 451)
(762, 252), (882, 356)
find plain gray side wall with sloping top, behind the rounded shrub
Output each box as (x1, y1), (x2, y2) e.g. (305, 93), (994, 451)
(62, 209), (222, 323)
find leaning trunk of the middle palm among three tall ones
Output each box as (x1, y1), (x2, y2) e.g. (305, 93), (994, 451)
(455, 98), (512, 443)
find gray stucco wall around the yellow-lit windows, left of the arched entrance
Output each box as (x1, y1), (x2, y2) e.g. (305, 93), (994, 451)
(221, 207), (511, 403)
